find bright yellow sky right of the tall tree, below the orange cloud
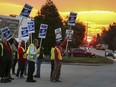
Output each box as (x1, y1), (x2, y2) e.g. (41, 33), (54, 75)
(60, 11), (116, 35)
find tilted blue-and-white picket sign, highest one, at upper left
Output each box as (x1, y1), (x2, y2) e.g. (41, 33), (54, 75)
(20, 4), (33, 17)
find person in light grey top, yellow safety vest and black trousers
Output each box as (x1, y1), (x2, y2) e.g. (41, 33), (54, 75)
(26, 39), (38, 82)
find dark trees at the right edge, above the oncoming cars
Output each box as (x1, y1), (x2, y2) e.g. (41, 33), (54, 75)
(97, 22), (116, 51)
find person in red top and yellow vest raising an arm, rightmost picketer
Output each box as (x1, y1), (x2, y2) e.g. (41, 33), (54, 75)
(50, 38), (67, 82)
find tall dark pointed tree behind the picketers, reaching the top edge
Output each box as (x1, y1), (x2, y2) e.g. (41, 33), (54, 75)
(35, 0), (63, 54)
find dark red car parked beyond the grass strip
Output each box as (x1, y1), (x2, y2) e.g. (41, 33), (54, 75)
(68, 48), (95, 57)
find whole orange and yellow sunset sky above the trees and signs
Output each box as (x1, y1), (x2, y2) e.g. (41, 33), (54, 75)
(0, 0), (116, 35)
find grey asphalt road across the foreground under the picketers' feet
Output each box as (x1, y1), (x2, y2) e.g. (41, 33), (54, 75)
(0, 49), (116, 87)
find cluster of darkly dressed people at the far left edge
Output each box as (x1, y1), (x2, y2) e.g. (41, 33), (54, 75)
(0, 38), (17, 83)
